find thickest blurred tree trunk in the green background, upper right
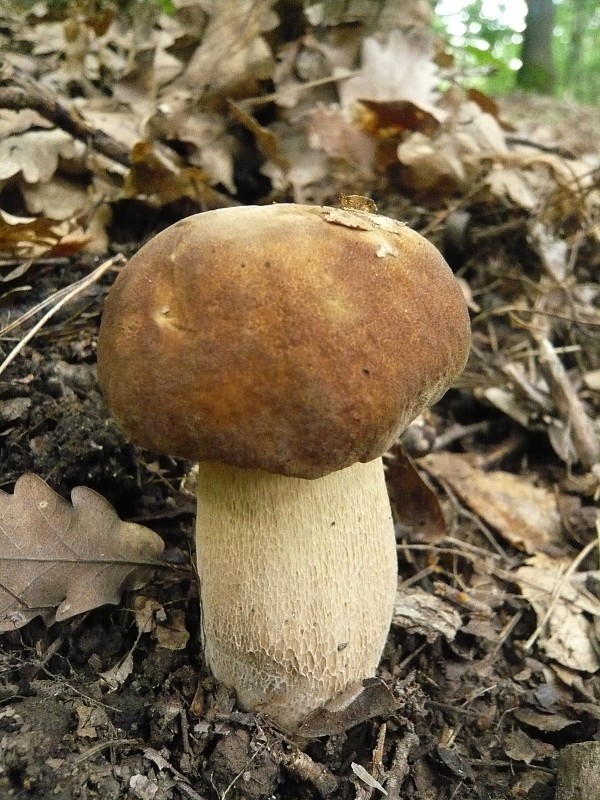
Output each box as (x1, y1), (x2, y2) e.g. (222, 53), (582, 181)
(517, 0), (556, 94)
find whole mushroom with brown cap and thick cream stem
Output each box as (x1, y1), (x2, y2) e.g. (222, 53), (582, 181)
(98, 204), (470, 731)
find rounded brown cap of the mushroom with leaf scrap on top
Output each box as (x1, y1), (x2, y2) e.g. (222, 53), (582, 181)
(98, 204), (470, 478)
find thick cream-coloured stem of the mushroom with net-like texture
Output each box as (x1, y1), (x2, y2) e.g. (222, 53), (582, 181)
(196, 458), (397, 730)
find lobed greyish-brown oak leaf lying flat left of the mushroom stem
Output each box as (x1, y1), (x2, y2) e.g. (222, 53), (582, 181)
(0, 474), (163, 632)
